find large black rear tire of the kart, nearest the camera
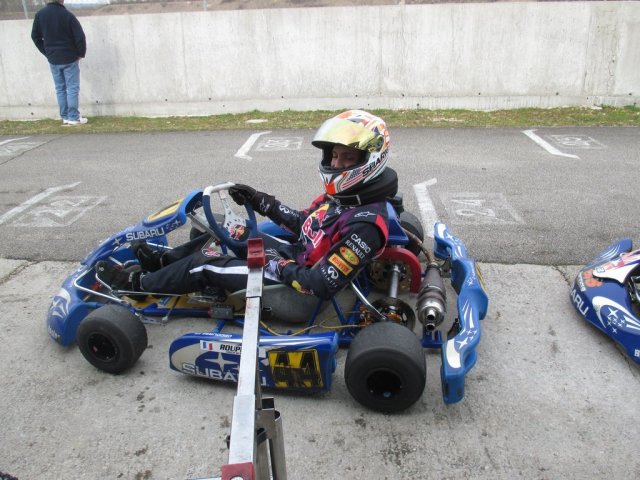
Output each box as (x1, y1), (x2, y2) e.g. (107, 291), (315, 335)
(344, 322), (427, 413)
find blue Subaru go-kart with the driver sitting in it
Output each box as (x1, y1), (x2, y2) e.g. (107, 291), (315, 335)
(47, 183), (488, 412)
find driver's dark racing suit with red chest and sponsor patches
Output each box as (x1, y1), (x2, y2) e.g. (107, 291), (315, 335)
(141, 195), (388, 299)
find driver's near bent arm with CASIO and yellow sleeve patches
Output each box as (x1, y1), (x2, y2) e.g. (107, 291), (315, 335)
(280, 222), (385, 300)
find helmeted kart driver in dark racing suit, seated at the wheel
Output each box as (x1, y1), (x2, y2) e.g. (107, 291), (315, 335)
(96, 110), (398, 299)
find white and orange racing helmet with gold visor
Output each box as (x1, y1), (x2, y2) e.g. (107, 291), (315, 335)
(311, 110), (391, 196)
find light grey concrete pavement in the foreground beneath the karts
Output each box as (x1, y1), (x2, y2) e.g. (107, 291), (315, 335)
(0, 260), (640, 480)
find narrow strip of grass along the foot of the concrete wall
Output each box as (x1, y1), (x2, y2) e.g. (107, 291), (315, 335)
(0, 106), (640, 135)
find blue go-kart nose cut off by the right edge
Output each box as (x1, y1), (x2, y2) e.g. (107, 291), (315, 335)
(571, 238), (640, 363)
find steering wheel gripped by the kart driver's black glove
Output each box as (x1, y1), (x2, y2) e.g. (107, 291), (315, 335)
(202, 182), (258, 248)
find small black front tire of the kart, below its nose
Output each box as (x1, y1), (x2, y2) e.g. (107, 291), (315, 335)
(76, 305), (148, 374)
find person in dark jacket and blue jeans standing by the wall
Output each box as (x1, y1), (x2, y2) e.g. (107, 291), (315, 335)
(31, 0), (87, 125)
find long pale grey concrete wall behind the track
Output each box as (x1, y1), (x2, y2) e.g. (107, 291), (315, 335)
(0, 2), (640, 119)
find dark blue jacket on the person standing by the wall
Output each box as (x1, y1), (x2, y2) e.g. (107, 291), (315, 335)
(31, 1), (87, 65)
